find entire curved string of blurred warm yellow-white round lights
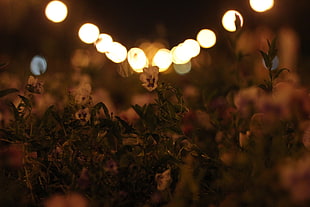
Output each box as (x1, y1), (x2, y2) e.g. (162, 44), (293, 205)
(41, 0), (274, 74)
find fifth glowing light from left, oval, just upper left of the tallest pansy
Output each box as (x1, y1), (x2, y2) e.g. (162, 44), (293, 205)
(127, 47), (148, 73)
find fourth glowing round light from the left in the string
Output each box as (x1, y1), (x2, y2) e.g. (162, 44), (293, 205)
(105, 42), (127, 63)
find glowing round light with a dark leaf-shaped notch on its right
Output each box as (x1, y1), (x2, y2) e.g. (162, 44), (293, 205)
(222, 10), (243, 32)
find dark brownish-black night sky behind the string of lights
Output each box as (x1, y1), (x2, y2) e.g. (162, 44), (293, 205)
(0, 0), (310, 66)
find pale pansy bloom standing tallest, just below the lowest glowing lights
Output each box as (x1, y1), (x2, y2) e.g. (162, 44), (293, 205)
(140, 66), (159, 91)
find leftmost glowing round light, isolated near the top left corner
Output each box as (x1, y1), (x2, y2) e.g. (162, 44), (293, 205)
(45, 1), (68, 23)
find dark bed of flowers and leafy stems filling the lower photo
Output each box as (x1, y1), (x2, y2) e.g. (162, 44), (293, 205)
(0, 39), (310, 207)
